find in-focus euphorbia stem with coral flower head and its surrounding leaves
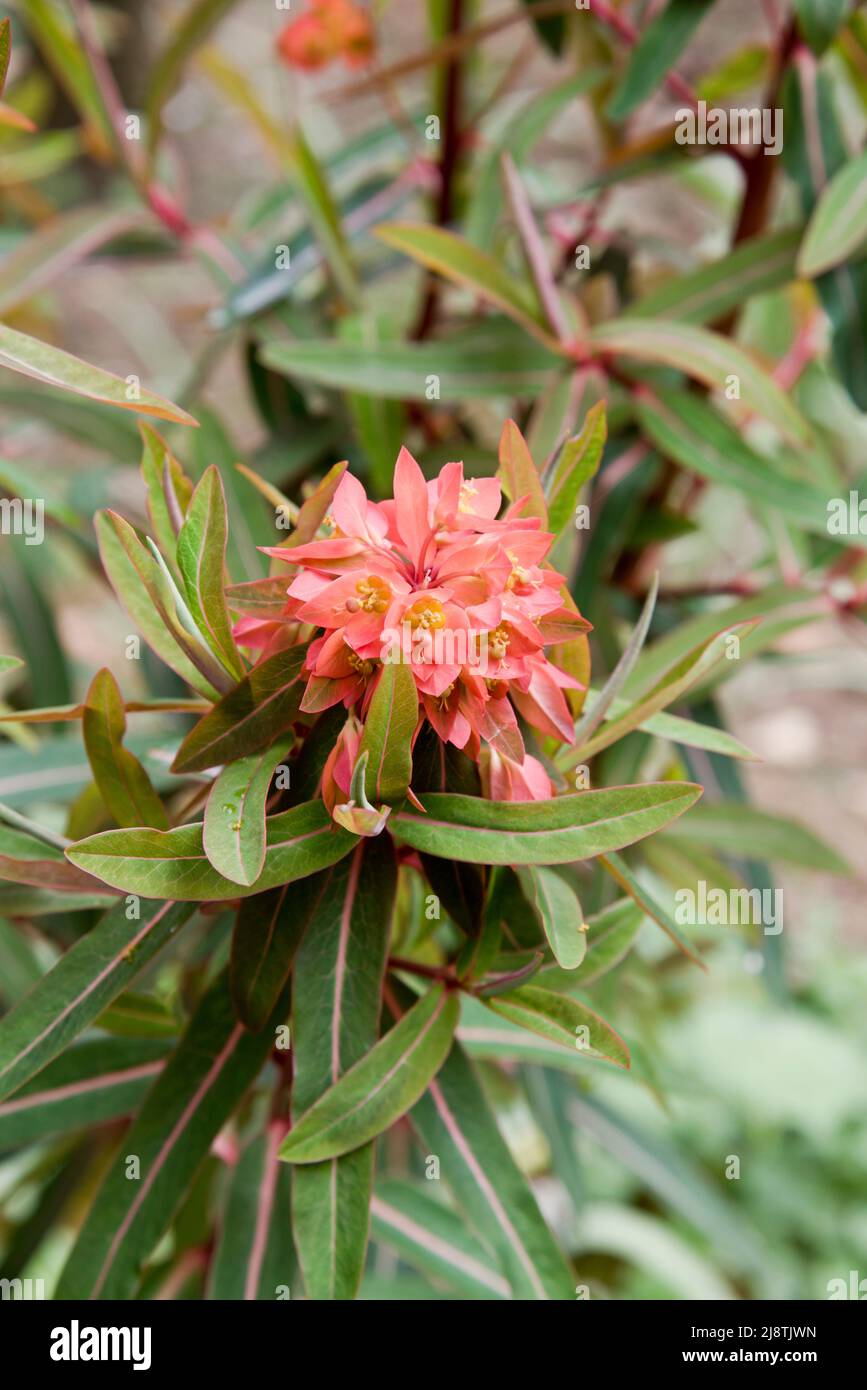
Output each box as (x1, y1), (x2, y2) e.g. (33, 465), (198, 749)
(0, 411), (718, 1298)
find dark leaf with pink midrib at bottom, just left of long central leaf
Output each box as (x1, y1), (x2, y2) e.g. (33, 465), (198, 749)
(208, 1119), (295, 1302)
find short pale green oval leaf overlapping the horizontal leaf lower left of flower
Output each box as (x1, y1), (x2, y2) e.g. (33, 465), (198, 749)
(201, 735), (295, 887)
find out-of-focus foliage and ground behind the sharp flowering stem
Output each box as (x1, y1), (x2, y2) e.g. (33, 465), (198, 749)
(0, 0), (867, 1300)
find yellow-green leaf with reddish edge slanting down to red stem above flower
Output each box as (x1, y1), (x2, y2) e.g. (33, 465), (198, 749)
(377, 222), (556, 348)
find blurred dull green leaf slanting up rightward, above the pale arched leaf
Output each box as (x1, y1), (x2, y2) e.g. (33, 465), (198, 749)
(629, 227), (802, 324)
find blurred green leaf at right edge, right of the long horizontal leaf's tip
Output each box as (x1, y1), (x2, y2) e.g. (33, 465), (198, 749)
(661, 801), (852, 874)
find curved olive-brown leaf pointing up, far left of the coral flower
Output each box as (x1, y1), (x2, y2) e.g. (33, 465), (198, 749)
(82, 667), (168, 830)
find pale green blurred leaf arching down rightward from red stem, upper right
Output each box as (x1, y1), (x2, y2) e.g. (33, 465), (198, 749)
(589, 318), (810, 443)
